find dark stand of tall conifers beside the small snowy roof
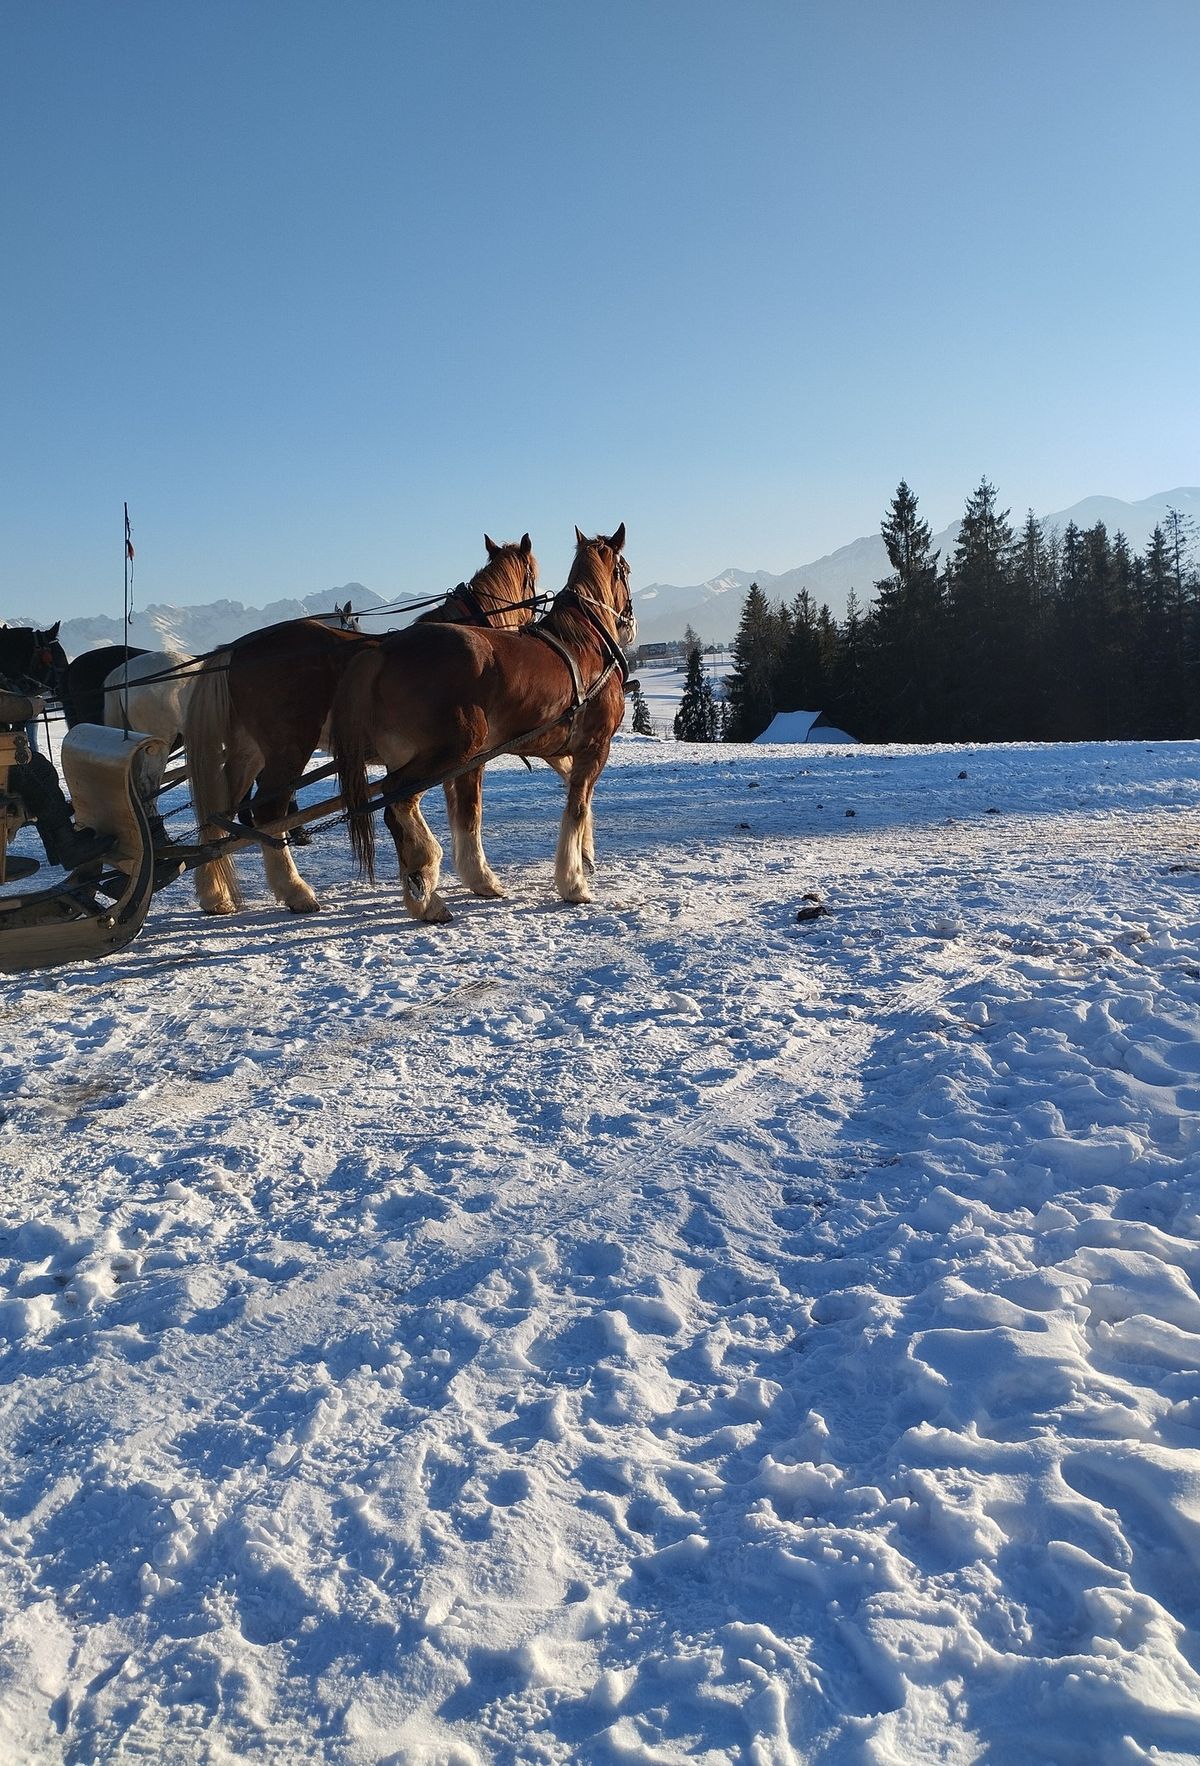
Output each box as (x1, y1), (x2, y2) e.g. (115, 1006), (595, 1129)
(712, 479), (1200, 742)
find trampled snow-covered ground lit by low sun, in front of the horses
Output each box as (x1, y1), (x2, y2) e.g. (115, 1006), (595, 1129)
(0, 738), (1200, 1766)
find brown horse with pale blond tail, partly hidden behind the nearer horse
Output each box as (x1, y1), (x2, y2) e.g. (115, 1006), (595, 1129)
(184, 533), (538, 913)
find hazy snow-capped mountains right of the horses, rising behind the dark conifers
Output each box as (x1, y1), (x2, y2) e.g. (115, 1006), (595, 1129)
(634, 487), (1200, 643)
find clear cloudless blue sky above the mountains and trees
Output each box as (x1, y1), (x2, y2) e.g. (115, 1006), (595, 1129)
(0, 0), (1200, 618)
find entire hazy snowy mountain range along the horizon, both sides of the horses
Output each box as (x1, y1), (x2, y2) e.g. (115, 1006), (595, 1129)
(11, 487), (1200, 655)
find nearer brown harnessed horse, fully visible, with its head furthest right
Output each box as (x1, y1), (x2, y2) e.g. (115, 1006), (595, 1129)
(330, 523), (637, 920)
